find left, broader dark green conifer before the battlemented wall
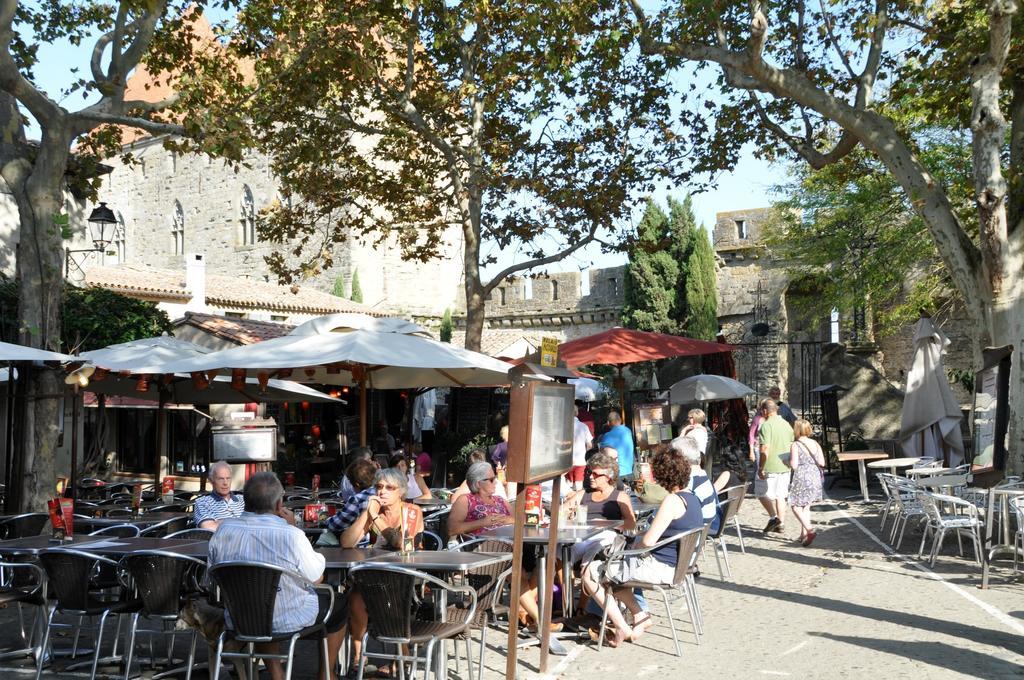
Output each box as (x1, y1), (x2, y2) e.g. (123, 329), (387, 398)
(623, 199), (682, 334)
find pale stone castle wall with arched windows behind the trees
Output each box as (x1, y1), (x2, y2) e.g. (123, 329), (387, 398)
(62, 139), (462, 314)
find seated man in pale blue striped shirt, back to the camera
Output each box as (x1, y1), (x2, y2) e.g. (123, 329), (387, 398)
(207, 472), (348, 680)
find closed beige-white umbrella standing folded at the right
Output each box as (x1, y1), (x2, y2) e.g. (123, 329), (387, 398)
(899, 318), (964, 466)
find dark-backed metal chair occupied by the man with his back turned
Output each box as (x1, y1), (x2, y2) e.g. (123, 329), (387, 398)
(208, 561), (334, 680)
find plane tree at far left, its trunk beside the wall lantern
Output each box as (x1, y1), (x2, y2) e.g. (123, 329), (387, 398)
(0, 0), (247, 509)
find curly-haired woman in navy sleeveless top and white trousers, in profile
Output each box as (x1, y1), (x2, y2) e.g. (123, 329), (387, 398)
(583, 444), (703, 647)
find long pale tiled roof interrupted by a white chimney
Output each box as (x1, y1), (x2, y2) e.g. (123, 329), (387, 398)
(85, 264), (386, 316)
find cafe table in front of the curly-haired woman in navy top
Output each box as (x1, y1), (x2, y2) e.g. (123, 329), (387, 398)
(479, 519), (623, 655)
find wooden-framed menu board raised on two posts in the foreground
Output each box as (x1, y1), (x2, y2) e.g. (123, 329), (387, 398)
(506, 380), (575, 484)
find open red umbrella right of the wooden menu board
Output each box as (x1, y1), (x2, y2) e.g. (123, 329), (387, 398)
(558, 327), (735, 409)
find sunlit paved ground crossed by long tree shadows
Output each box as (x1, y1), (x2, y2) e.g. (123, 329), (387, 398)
(6, 481), (1024, 680)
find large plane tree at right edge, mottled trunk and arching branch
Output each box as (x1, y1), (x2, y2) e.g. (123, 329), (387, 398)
(628, 0), (1024, 470)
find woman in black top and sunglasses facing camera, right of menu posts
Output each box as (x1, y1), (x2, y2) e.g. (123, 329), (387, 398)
(565, 452), (637, 564)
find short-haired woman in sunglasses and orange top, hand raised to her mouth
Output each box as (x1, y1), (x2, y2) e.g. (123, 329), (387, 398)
(341, 468), (423, 675)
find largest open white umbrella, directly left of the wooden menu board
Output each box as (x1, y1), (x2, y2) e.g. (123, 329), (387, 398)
(136, 314), (512, 444)
